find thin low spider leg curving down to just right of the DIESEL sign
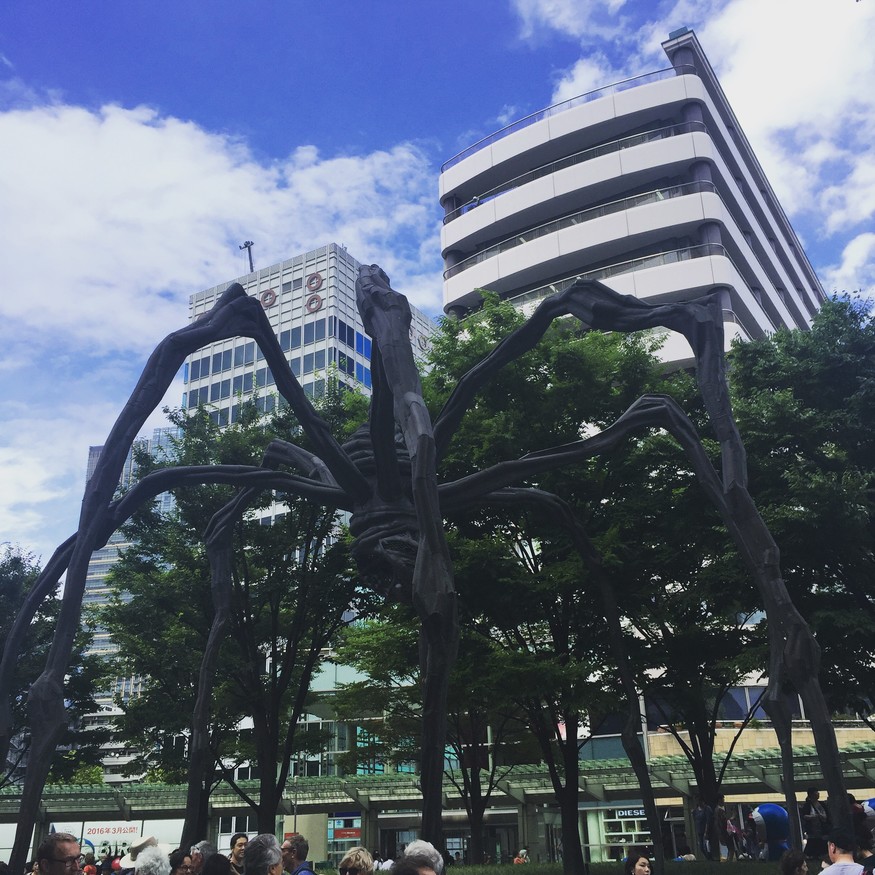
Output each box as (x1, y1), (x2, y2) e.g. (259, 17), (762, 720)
(468, 486), (665, 871)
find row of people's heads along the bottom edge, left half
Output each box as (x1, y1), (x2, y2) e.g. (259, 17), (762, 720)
(0, 832), (445, 875)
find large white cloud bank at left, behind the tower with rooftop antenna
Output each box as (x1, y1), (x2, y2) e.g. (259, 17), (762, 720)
(0, 92), (441, 557)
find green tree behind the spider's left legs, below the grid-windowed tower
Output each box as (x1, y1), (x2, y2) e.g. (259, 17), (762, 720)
(99, 392), (370, 832)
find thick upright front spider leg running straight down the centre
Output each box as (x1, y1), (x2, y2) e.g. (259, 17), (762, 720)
(356, 265), (459, 847)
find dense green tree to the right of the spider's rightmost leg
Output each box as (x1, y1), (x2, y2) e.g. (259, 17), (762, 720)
(730, 297), (875, 719)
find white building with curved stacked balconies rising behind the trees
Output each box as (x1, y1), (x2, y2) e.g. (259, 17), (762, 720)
(440, 28), (824, 361)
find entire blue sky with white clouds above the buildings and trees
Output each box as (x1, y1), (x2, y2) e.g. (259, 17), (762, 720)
(0, 0), (875, 560)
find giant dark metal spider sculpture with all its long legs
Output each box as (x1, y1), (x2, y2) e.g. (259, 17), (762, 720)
(0, 265), (846, 871)
